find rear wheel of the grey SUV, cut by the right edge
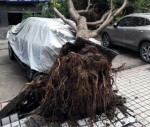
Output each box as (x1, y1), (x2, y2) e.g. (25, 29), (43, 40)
(140, 42), (150, 63)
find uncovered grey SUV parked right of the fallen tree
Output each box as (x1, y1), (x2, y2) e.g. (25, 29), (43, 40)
(101, 13), (150, 63)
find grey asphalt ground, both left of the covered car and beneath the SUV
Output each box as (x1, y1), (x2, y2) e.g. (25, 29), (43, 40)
(0, 40), (145, 101)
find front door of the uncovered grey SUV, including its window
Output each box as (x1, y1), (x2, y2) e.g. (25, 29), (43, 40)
(111, 17), (132, 44)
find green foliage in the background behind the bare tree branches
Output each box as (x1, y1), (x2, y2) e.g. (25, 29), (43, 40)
(23, 0), (150, 23)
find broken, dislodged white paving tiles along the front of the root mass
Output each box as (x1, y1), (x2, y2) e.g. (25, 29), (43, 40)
(0, 109), (142, 127)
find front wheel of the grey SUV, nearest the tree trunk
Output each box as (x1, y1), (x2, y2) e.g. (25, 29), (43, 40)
(102, 33), (111, 48)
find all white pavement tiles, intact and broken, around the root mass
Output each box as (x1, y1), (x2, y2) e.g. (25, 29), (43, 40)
(0, 65), (150, 127)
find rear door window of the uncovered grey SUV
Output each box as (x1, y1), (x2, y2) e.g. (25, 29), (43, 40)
(131, 17), (145, 26)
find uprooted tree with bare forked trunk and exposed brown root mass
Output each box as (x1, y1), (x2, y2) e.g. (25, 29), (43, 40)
(0, 0), (127, 121)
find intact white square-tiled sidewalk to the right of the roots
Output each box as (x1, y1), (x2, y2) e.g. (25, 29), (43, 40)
(115, 65), (150, 127)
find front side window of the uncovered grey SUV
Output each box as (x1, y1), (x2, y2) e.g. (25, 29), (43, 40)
(117, 17), (132, 27)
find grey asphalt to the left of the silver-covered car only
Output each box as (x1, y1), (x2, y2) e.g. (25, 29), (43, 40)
(0, 40), (27, 101)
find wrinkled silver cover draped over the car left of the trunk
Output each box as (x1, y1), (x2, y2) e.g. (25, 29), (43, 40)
(7, 17), (75, 72)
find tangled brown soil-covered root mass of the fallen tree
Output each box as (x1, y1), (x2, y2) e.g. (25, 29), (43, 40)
(0, 43), (116, 122)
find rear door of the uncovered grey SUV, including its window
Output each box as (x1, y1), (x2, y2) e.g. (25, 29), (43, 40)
(125, 17), (146, 47)
